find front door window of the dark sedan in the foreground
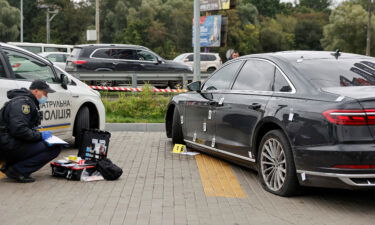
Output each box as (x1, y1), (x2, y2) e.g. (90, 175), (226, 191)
(203, 61), (242, 90)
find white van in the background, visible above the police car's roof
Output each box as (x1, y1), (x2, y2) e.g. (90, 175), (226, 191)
(8, 42), (73, 54)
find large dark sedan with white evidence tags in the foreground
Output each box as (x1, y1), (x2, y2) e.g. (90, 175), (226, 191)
(166, 51), (375, 196)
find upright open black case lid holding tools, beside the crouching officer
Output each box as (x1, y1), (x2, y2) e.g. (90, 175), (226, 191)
(78, 129), (111, 161)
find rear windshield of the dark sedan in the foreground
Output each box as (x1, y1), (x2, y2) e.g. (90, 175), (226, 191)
(295, 58), (375, 88)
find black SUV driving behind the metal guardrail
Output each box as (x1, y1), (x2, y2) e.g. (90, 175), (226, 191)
(65, 44), (192, 86)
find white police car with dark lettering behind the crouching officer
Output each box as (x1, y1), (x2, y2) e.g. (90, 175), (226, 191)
(0, 43), (105, 145)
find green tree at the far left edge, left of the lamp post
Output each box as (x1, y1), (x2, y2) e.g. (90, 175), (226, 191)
(0, 0), (20, 42)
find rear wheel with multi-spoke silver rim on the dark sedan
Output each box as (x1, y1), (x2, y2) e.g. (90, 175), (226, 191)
(258, 130), (299, 197)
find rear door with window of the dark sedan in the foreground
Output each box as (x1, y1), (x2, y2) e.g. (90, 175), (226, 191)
(215, 59), (276, 160)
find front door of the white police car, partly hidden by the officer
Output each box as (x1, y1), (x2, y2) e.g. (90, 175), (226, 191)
(4, 48), (74, 137)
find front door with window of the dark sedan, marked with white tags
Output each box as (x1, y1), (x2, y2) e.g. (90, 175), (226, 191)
(185, 61), (242, 148)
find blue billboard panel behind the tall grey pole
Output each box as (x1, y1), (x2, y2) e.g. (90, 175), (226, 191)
(192, 15), (221, 47)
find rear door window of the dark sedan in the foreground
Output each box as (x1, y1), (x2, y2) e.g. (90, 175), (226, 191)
(232, 60), (275, 91)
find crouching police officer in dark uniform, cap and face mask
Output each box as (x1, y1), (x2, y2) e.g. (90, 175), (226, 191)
(0, 80), (60, 183)
